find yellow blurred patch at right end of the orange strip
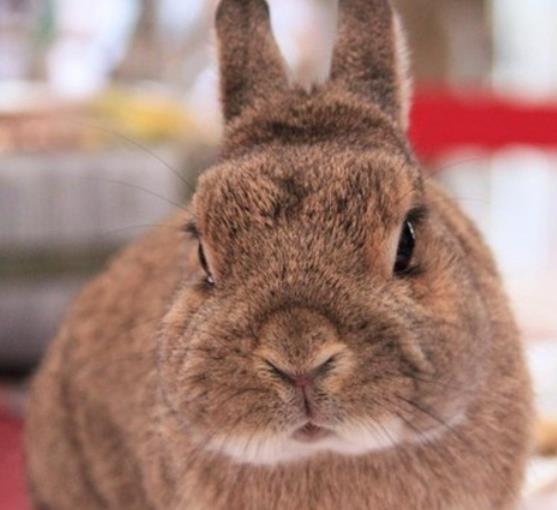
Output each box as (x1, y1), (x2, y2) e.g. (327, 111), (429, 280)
(91, 89), (195, 142)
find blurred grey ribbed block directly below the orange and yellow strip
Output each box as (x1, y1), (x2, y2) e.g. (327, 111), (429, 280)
(0, 148), (179, 250)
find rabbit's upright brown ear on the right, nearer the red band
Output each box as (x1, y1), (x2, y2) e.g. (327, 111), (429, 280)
(331, 0), (409, 127)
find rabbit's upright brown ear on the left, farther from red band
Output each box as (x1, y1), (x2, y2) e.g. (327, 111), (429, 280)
(216, 0), (288, 122)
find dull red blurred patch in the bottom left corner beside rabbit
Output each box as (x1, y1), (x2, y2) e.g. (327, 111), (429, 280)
(0, 408), (30, 510)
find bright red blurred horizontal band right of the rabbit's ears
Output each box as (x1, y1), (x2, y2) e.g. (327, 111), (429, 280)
(410, 89), (557, 161)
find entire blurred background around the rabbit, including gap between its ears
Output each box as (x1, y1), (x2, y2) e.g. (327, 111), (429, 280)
(0, 0), (557, 509)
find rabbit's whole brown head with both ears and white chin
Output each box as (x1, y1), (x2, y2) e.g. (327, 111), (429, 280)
(159, 0), (504, 464)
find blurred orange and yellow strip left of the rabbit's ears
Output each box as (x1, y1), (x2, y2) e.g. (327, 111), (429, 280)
(0, 85), (205, 153)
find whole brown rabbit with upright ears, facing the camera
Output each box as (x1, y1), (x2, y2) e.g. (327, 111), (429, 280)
(27, 0), (531, 510)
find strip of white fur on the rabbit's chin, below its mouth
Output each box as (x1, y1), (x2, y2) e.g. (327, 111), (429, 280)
(208, 418), (405, 465)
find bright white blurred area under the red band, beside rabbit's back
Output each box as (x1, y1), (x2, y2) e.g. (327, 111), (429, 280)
(439, 147), (557, 342)
